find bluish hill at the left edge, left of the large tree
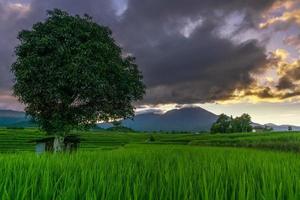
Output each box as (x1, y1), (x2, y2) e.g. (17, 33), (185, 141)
(0, 110), (30, 127)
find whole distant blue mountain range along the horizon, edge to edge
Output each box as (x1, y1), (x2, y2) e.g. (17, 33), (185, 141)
(0, 107), (300, 131)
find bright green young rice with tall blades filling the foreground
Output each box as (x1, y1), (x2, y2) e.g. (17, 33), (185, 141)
(0, 144), (300, 200)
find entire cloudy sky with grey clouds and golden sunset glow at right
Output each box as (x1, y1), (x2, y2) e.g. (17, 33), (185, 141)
(0, 0), (300, 125)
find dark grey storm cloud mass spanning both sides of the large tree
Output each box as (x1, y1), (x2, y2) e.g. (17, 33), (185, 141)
(0, 0), (275, 109)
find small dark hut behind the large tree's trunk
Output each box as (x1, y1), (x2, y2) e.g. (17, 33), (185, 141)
(31, 135), (80, 153)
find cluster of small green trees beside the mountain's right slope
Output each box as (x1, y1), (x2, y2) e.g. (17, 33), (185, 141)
(210, 113), (252, 133)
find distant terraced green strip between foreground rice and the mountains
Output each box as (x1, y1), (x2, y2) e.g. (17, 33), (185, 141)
(0, 129), (300, 153)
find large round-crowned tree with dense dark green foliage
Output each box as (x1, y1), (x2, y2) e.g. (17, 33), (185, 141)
(12, 9), (145, 142)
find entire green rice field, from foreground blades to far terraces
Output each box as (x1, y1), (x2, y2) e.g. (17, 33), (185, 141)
(0, 129), (300, 200)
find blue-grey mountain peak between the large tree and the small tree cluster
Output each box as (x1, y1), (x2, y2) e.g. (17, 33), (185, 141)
(100, 107), (218, 131)
